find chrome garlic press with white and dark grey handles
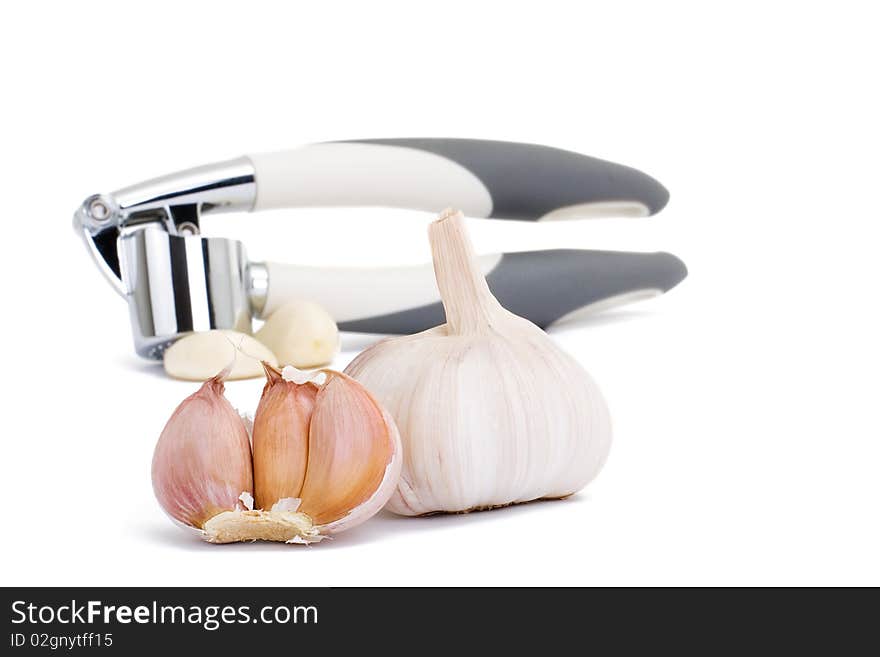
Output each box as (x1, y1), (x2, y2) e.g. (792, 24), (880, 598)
(74, 139), (687, 359)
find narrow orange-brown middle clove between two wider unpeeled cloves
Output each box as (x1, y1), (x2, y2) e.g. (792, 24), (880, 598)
(253, 363), (318, 509)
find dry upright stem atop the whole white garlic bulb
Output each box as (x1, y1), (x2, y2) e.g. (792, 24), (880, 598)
(428, 209), (498, 335)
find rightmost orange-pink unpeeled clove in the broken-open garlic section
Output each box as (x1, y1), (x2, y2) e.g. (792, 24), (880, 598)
(300, 371), (400, 533)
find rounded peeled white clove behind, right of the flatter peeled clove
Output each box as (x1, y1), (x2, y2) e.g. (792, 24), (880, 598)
(256, 301), (339, 368)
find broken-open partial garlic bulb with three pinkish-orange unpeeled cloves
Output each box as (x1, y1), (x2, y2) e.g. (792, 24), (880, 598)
(153, 363), (401, 543)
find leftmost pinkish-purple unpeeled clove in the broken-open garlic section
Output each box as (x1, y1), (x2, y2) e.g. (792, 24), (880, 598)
(152, 377), (253, 529)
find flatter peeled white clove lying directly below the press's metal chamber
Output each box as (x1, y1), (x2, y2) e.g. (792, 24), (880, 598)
(163, 330), (278, 381)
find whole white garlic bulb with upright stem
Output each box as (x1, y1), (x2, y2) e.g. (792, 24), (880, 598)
(345, 211), (611, 515)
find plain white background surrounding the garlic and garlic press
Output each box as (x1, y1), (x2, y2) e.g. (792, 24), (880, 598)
(0, 0), (880, 585)
